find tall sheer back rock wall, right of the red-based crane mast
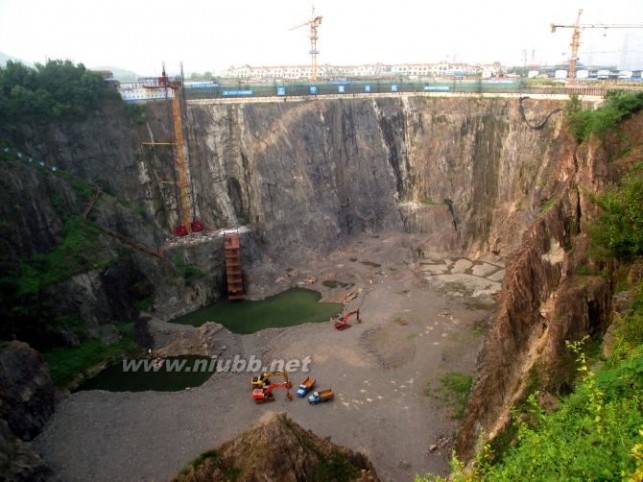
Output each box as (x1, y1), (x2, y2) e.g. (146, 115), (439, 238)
(184, 97), (562, 259)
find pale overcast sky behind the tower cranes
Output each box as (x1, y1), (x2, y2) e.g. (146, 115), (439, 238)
(0, 0), (643, 75)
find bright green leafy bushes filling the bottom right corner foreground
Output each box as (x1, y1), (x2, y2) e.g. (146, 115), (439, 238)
(416, 342), (643, 482)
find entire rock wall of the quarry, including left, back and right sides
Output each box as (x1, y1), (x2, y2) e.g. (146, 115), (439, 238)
(0, 92), (632, 468)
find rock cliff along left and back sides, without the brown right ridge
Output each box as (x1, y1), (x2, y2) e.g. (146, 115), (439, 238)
(0, 96), (562, 329)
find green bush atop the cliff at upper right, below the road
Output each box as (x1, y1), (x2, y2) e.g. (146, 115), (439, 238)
(566, 90), (643, 142)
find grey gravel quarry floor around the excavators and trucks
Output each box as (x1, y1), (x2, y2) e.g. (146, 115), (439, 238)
(34, 234), (504, 482)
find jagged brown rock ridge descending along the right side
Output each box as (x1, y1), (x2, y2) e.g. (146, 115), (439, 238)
(457, 114), (643, 458)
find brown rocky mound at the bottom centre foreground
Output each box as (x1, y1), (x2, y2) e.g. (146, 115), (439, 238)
(174, 412), (379, 482)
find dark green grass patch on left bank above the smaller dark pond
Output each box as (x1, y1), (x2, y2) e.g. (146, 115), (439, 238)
(43, 323), (140, 387)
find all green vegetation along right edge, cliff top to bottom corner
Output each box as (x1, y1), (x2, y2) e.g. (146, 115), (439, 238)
(416, 99), (643, 482)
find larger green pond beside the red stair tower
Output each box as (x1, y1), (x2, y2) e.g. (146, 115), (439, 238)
(172, 288), (343, 334)
